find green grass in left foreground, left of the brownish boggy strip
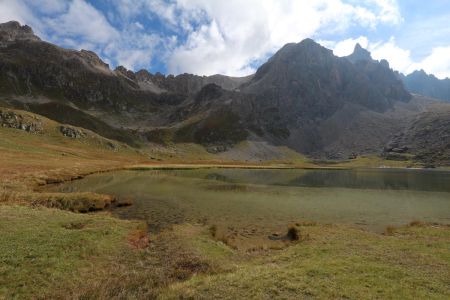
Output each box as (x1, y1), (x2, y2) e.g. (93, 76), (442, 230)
(0, 205), (142, 299)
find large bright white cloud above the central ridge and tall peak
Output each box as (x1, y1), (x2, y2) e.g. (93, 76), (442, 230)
(161, 0), (401, 75)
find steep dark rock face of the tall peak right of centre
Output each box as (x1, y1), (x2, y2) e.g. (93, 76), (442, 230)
(236, 39), (411, 158)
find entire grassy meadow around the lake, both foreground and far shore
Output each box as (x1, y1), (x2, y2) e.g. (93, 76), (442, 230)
(0, 106), (450, 299)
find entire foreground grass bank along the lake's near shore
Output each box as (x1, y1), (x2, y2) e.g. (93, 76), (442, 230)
(0, 205), (450, 299)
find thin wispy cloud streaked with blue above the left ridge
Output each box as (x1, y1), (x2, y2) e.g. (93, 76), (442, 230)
(0, 0), (173, 69)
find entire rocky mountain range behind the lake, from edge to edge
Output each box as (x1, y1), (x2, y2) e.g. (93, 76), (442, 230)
(0, 22), (450, 164)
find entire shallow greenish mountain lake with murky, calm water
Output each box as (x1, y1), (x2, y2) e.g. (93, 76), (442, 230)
(52, 169), (450, 235)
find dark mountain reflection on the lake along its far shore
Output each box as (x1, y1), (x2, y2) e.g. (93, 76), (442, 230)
(167, 169), (450, 192)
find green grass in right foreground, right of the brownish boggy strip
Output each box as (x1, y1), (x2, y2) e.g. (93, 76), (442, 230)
(161, 225), (450, 299)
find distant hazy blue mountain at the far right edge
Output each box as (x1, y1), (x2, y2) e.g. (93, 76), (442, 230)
(401, 70), (450, 101)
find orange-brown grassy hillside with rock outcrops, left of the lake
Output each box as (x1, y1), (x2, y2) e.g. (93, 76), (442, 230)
(0, 107), (147, 185)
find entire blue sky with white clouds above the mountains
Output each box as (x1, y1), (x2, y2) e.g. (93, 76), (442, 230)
(0, 0), (450, 79)
